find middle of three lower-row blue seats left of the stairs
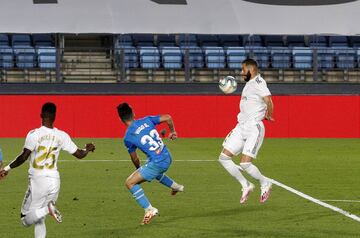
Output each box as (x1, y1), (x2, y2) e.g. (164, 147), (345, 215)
(13, 45), (36, 69)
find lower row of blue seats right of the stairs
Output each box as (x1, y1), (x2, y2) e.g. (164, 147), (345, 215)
(115, 46), (360, 69)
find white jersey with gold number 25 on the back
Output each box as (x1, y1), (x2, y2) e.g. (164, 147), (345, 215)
(24, 126), (78, 178)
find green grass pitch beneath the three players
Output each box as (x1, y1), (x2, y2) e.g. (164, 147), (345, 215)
(0, 139), (360, 238)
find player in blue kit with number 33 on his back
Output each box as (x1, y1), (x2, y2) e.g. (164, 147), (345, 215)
(117, 103), (184, 225)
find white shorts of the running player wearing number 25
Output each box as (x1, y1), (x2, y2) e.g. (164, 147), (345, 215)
(21, 176), (60, 215)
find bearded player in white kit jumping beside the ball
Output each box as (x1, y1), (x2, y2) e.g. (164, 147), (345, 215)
(219, 59), (274, 203)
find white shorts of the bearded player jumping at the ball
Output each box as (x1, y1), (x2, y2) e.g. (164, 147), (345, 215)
(223, 121), (265, 159)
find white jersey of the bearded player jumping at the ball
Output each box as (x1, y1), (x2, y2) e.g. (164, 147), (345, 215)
(237, 74), (271, 124)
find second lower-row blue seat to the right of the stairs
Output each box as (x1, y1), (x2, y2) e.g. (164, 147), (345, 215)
(139, 46), (160, 69)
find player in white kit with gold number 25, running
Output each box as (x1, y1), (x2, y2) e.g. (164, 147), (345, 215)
(0, 103), (95, 238)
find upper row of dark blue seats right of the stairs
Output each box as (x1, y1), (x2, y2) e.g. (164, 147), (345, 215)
(114, 34), (360, 47)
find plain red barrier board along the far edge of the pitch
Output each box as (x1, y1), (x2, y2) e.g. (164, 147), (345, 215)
(0, 95), (360, 138)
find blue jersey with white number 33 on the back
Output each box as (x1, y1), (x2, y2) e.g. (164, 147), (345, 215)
(124, 116), (171, 166)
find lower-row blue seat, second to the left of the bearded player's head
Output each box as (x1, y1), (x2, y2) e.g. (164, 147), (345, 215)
(203, 46), (225, 69)
